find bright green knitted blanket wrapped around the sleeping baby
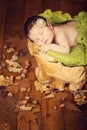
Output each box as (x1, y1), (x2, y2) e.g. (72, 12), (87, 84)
(40, 9), (87, 66)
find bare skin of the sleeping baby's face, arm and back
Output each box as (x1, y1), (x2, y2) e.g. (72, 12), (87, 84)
(29, 21), (78, 54)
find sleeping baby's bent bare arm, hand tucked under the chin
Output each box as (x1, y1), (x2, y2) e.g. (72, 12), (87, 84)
(41, 30), (71, 54)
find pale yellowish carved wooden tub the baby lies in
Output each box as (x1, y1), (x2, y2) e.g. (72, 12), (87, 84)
(28, 40), (86, 91)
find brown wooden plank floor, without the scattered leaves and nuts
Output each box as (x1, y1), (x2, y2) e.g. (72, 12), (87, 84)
(0, 0), (87, 130)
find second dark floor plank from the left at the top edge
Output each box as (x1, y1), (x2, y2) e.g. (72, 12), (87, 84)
(4, 0), (29, 60)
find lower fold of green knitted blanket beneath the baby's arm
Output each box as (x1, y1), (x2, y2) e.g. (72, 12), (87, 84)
(47, 44), (87, 66)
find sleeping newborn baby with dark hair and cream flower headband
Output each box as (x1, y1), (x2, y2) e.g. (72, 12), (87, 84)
(24, 15), (78, 54)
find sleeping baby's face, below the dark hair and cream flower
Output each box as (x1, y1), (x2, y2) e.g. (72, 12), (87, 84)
(29, 20), (54, 46)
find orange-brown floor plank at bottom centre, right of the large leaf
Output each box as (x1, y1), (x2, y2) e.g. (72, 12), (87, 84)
(42, 98), (63, 130)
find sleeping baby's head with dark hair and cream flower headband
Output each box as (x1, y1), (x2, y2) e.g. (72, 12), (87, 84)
(24, 15), (53, 46)
